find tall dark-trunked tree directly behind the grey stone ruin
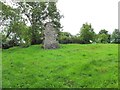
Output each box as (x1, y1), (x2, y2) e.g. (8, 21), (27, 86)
(19, 2), (61, 44)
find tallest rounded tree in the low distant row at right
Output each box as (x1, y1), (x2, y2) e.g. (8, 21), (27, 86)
(80, 23), (95, 44)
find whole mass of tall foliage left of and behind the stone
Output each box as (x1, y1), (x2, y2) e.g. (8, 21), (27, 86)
(0, 2), (61, 48)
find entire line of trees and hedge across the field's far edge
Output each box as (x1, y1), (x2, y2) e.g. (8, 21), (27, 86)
(0, 2), (120, 48)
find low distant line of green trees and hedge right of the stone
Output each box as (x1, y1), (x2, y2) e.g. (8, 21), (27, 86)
(59, 23), (120, 44)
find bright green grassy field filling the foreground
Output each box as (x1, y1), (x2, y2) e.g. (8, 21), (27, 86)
(2, 44), (118, 88)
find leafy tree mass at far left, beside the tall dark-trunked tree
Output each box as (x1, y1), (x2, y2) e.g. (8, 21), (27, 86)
(0, 2), (30, 48)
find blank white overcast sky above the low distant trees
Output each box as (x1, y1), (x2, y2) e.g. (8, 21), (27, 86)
(57, 0), (119, 35)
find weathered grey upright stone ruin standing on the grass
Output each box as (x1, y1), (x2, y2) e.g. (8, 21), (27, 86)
(43, 22), (59, 49)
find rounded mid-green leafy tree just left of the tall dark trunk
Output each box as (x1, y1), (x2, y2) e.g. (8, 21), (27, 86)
(11, 22), (31, 47)
